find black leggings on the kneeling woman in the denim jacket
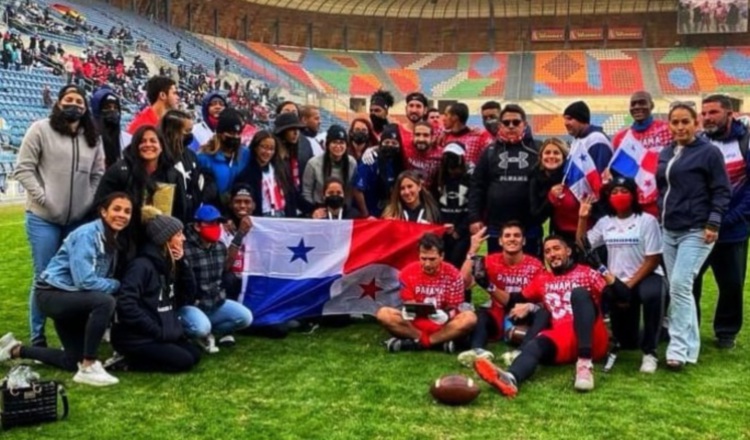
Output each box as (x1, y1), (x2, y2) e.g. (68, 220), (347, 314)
(20, 289), (115, 371)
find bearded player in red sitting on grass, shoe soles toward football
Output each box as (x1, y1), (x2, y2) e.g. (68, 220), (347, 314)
(474, 235), (614, 397)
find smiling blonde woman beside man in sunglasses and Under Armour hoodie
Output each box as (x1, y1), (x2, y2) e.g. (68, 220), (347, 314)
(529, 138), (579, 243)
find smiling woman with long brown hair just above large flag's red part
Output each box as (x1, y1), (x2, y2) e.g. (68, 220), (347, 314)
(382, 171), (440, 223)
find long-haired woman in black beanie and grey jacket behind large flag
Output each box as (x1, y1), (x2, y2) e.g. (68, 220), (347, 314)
(302, 124), (357, 210)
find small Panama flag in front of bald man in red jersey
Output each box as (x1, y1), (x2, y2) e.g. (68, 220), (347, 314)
(609, 130), (659, 198)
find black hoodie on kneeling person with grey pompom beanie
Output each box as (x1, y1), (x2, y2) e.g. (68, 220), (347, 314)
(112, 243), (195, 348)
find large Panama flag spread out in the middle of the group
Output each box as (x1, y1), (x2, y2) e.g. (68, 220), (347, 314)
(242, 217), (444, 325)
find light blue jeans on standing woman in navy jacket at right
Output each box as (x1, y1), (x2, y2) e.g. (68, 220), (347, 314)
(663, 229), (714, 363)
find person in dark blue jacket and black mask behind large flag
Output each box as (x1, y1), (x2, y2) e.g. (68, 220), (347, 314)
(354, 125), (404, 217)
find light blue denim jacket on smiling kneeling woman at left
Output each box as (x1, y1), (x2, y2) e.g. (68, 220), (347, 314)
(40, 219), (120, 294)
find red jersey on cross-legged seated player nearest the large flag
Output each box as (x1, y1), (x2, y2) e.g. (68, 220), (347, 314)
(399, 261), (464, 310)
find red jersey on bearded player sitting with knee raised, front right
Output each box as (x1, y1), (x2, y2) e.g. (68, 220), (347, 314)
(522, 264), (606, 327)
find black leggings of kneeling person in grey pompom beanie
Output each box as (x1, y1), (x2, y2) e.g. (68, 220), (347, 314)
(115, 341), (201, 373)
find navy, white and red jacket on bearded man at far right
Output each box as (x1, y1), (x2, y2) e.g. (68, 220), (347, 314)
(704, 121), (750, 243)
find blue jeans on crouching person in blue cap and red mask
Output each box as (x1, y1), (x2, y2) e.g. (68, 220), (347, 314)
(177, 299), (253, 338)
